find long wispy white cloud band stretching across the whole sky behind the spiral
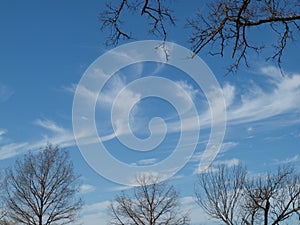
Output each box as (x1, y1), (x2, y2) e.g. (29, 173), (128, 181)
(0, 67), (300, 167)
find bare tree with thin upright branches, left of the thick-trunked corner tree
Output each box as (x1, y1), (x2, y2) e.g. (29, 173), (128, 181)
(195, 165), (246, 225)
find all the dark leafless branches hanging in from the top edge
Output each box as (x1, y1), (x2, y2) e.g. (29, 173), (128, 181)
(100, 0), (300, 72)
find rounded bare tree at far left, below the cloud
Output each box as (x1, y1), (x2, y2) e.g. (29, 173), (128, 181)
(4, 144), (82, 225)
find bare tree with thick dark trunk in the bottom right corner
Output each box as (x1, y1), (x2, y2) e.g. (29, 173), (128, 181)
(244, 166), (300, 225)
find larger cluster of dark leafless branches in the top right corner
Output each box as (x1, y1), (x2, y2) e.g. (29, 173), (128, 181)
(187, 0), (300, 72)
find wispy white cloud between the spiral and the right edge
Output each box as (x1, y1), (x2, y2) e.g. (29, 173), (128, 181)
(227, 67), (300, 124)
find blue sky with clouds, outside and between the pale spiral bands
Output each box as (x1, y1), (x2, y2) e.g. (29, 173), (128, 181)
(0, 0), (300, 225)
